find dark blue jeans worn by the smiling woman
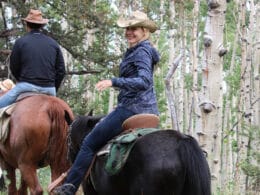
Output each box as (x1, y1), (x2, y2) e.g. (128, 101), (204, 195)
(65, 107), (135, 193)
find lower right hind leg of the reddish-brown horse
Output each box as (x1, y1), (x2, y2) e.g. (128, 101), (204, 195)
(19, 164), (43, 195)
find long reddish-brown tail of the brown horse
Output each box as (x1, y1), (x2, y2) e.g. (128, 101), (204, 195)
(48, 97), (74, 177)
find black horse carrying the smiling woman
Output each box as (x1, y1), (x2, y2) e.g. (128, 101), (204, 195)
(69, 112), (211, 195)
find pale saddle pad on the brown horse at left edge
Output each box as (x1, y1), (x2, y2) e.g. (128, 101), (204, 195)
(0, 103), (15, 143)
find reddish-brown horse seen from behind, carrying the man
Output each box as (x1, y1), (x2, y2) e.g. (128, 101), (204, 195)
(0, 95), (73, 195)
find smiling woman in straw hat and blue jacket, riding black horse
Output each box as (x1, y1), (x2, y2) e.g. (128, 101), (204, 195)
(53, 11), (159, 195)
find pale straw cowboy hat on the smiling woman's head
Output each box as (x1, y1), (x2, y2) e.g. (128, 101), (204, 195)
(117, 11), (157, 33)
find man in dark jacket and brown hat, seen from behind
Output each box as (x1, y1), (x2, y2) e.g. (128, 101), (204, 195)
(0, 9), (65, 108)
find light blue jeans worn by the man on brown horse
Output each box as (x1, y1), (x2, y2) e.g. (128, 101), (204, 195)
(0, 82), (56, 108)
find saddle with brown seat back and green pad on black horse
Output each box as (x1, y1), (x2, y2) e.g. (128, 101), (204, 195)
(97, 114), (159, 175)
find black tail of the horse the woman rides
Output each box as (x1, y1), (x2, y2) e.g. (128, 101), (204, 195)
(179, 135), (211, 195)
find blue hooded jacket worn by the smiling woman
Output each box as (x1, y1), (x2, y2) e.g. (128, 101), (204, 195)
(112, 40), (160, 115)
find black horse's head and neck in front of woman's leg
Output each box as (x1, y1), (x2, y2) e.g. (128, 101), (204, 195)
(68, 112), (104, 162)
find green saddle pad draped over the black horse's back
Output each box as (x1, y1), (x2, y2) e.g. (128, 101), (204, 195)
(105, 128), (159, 175)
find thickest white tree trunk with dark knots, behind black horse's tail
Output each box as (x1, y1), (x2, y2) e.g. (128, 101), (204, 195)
(200, 0), (226, 192)
